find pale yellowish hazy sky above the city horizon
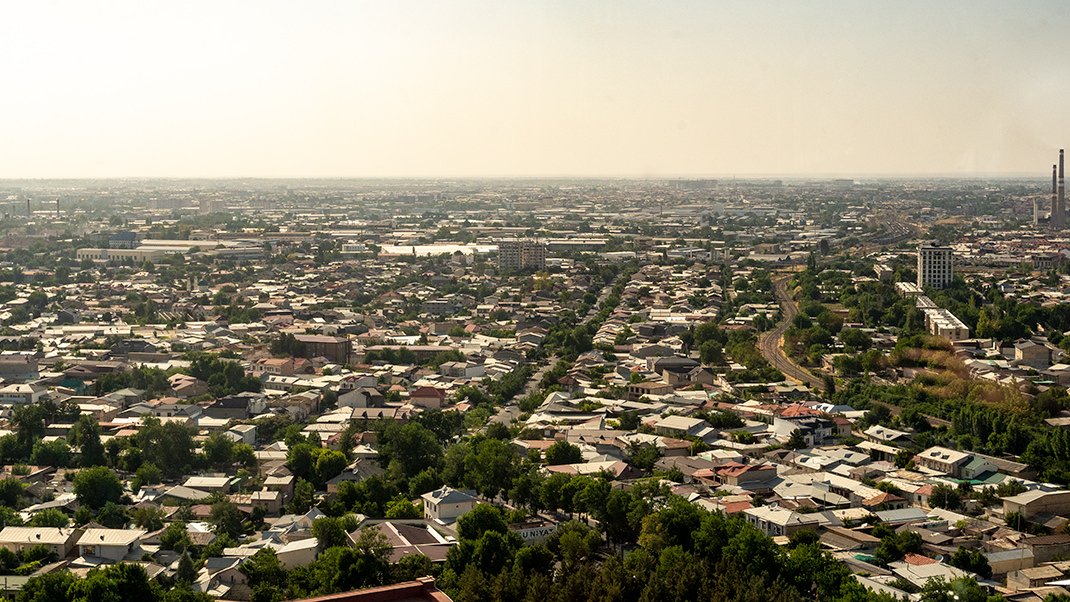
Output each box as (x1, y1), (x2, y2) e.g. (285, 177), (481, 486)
(0, 0), (1070, 177)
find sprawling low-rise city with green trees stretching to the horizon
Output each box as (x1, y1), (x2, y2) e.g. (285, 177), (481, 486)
(0, 172), (1070, 602)
